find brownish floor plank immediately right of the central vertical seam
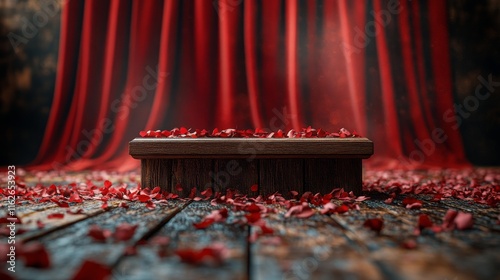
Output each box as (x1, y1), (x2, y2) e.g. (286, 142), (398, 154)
(251, 207), (387, 280)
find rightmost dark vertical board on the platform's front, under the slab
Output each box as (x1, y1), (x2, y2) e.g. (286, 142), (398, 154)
(304, 159), (363, 195)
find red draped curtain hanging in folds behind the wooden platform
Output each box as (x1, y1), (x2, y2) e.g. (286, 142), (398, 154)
(31, 0), (466, 170)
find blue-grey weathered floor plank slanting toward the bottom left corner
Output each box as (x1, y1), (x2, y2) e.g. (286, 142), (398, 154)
(15, 202), (184, 280)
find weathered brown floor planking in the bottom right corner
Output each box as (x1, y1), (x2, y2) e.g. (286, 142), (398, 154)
(330, 199), (500, 279)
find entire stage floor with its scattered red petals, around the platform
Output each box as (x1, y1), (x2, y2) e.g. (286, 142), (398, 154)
(0, 169), (500, 280)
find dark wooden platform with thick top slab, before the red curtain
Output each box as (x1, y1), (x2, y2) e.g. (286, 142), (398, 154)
(129, 138), (373, 196)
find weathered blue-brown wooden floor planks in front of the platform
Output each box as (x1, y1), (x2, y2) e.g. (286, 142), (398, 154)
(0, 170), (500, 280)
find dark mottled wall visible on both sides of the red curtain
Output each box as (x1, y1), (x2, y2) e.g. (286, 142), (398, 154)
(0, 0), (500, 166)
